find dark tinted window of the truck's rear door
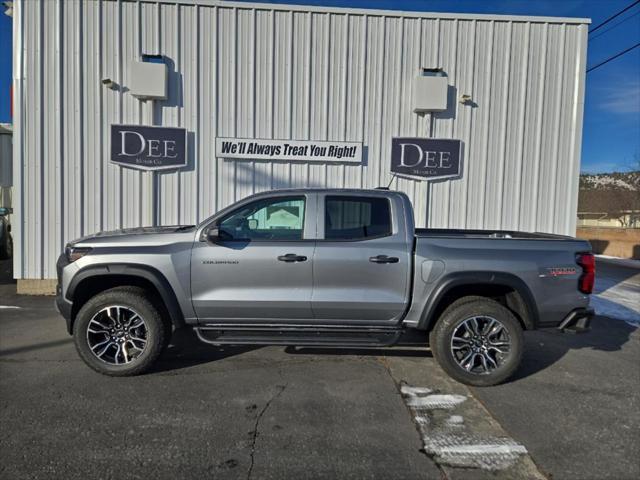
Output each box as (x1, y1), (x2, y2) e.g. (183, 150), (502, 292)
(324, 195), (391, 240)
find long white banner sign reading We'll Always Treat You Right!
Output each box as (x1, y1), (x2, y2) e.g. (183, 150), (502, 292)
(216, 138), (362, 163)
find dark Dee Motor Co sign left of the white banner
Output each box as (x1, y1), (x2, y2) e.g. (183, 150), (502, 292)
(111, 125), (187, 170)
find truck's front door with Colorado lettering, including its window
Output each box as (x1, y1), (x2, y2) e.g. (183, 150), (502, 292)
(191, 195), (315, 322)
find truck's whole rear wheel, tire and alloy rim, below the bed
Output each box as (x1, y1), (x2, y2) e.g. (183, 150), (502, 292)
(429, 297), (524, 387)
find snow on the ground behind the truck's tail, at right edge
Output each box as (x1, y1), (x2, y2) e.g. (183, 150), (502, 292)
(591, 256), (640, 325)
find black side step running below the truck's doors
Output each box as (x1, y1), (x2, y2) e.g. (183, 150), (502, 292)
(194, 324), (404, 347)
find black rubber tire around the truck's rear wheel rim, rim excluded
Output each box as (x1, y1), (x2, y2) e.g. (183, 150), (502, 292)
(429, 296), (524, 387)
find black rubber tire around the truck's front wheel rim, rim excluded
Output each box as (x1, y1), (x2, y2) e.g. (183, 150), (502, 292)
(73, 286), (170, 377)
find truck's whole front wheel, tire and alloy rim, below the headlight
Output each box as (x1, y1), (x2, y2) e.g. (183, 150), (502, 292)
(73, 287), (166, 376)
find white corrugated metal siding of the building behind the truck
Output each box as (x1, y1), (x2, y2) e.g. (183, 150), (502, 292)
(14, 0), (587, 278)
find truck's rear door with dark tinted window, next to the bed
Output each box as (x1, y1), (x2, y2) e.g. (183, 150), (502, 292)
(312, 193), (413, 324)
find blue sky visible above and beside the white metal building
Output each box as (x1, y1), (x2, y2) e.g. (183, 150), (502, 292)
(0, 0), (640, 172)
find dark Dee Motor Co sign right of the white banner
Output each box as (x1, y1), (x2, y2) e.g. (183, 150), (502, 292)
(391, 138), (462, 180)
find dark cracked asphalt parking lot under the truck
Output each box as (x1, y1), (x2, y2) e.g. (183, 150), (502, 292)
(0, 258), (640, 479)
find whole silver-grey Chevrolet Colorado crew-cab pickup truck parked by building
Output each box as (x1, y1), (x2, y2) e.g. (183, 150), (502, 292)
(56, 189), (595, 386)
